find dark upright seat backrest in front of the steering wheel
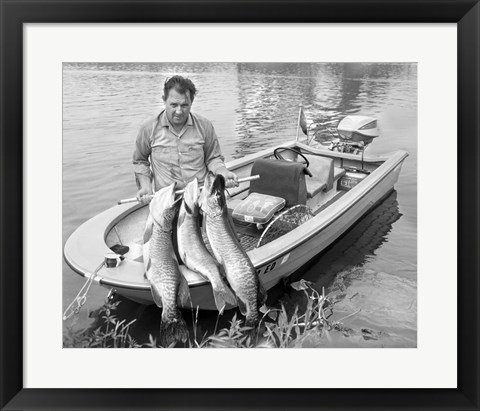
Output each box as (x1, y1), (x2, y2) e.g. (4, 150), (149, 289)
(250, 158), (307, 207)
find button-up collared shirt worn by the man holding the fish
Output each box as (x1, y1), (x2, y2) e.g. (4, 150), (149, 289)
(133, 111), (225, 191)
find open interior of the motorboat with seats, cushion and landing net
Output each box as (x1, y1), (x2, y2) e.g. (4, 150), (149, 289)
(105, 142), (383, 261)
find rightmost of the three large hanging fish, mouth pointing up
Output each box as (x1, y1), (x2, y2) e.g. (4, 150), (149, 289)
(201, 173), (267, 329)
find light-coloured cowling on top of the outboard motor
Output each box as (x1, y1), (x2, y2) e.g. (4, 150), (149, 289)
(337, 115), (380, 145)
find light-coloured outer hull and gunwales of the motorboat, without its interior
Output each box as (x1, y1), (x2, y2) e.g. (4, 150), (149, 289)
(64, 142), (408, 310)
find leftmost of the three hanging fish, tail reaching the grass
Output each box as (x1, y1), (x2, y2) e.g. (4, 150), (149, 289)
(143, 183), (190, 347)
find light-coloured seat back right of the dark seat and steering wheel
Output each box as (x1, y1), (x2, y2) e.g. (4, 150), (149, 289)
(306, 156), (345, 198)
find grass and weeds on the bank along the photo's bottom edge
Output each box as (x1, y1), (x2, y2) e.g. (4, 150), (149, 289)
(63, 280), (348, 348)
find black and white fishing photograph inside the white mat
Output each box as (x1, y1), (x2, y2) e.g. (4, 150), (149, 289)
(62, 62), (418, 348)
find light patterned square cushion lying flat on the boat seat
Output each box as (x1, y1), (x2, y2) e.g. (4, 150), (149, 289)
(232, 193), (285, 224)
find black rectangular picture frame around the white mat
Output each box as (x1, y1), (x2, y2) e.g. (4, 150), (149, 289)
(0, 0), (480, 410)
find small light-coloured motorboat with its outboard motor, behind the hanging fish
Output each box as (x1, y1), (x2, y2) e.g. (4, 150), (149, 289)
(64, 116), (408, 310)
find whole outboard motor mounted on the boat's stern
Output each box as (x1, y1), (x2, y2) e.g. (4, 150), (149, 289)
(331, 115), (380, 154)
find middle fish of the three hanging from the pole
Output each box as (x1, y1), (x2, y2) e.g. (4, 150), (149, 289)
(177, 178), (236, 314)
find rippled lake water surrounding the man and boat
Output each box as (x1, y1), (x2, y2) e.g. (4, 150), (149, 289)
(63, 63), (417, 347)
